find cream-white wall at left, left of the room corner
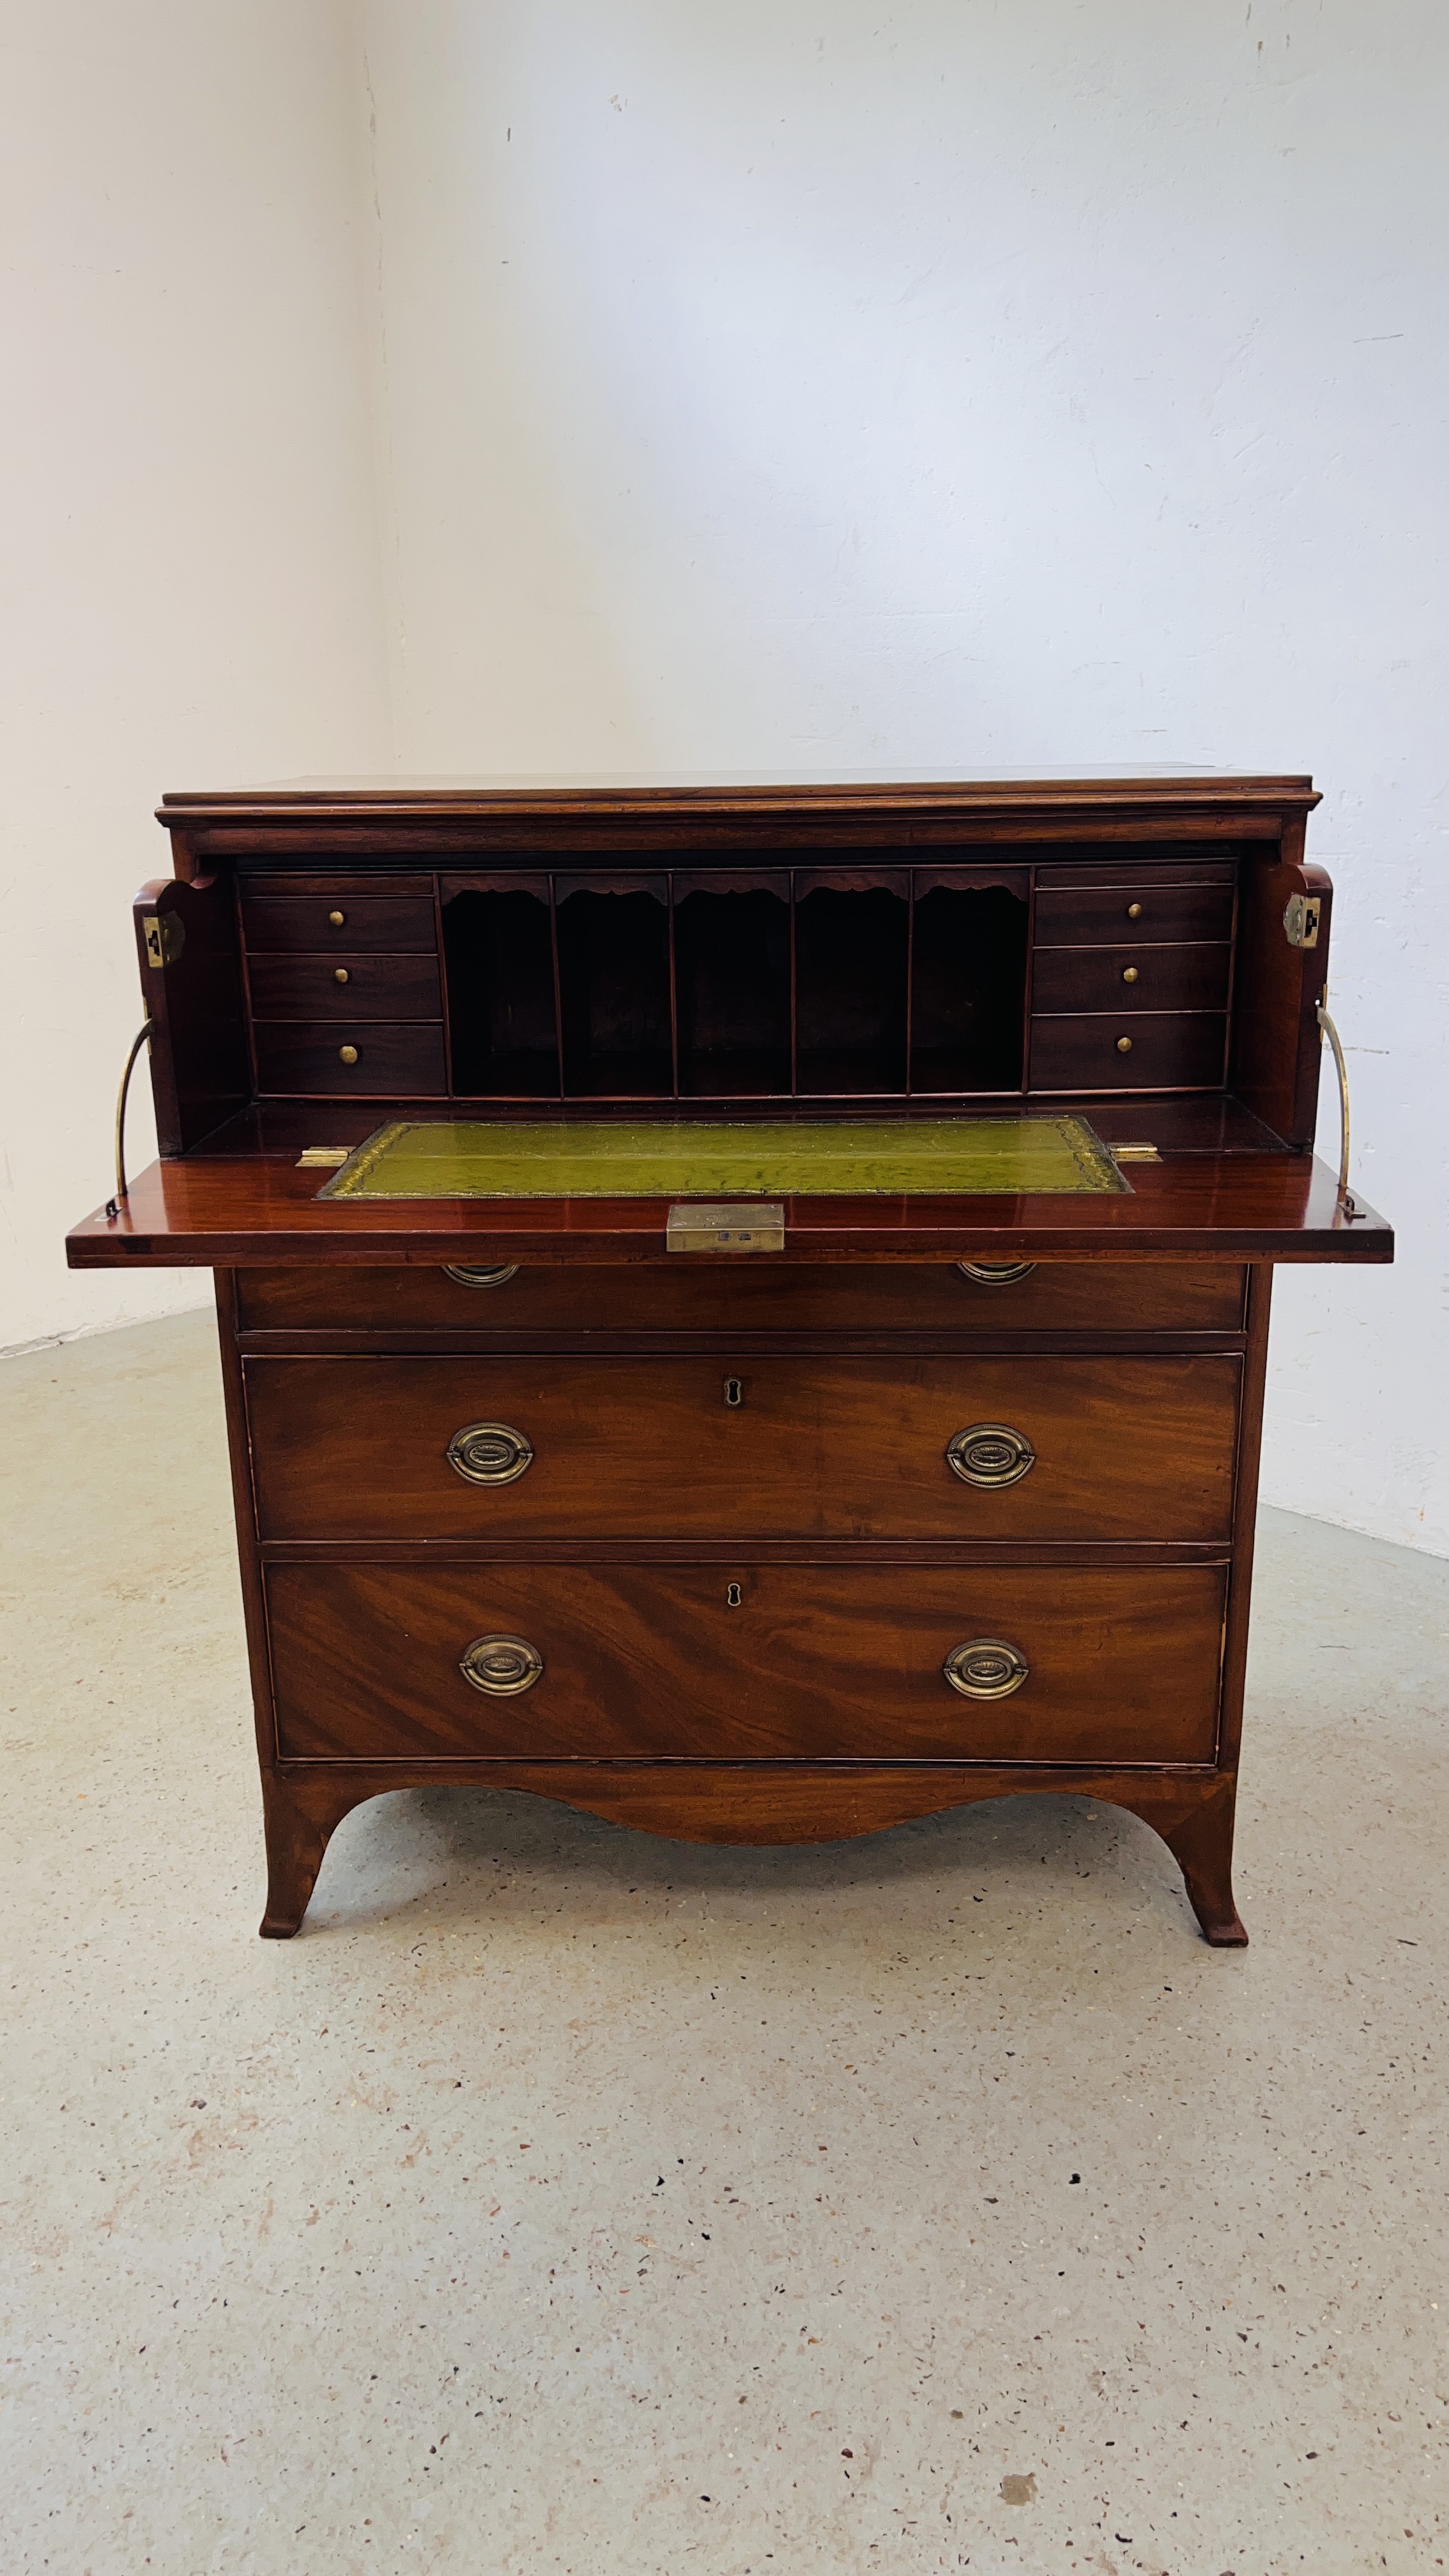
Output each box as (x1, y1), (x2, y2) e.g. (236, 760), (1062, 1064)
(0, 0), (389, 1345)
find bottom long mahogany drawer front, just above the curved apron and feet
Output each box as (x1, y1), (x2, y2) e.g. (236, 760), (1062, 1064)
(266, 1563), (1227, 1762)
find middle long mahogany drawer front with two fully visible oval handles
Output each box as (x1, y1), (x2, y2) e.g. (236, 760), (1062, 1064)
(245, 1353), (1240, 1543)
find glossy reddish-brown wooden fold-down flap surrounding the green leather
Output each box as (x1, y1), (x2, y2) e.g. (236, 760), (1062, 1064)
(67, 1149), (1392, 1270)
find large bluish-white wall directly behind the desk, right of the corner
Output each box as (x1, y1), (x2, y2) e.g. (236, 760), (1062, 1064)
(353, 0), (1449, 1553)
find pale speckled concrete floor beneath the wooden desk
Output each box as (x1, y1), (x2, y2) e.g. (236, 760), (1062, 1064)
(0, 1316), (1449, 2576)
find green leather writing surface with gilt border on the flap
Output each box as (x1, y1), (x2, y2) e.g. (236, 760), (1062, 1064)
(317, 1116), (1130, 1198)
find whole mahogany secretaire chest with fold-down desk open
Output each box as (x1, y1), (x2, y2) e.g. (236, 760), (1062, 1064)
(70, 773), (1392, 1942)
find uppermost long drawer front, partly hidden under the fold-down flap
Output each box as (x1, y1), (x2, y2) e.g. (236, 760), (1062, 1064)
(237, 1255), (1245, 1340)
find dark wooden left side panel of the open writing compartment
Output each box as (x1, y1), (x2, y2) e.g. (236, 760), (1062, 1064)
(132, 878), (252, 1154)
